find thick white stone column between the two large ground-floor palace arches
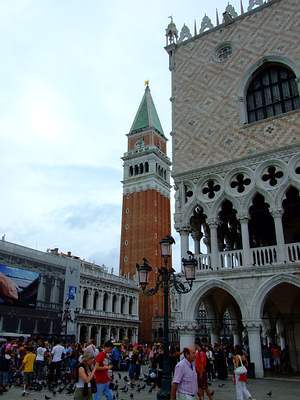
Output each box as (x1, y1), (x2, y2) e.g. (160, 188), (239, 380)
(244, 321), (264, 378)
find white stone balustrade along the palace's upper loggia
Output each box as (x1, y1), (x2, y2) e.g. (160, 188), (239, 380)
(195, 243), (300, 273)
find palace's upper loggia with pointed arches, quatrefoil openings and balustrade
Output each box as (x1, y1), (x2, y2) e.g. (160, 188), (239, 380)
(175, 155), (300, 270)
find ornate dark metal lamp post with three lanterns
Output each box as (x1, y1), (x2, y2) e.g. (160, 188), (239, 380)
(136, 236), (197, 400)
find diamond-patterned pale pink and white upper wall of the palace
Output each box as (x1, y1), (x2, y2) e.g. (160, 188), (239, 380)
(170, 0), (300, 176)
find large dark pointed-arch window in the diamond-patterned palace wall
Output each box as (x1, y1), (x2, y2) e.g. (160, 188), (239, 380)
(247, 63), (300, 123)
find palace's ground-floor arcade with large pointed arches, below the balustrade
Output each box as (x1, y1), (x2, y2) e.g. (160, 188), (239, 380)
(177, 266), (300, 377)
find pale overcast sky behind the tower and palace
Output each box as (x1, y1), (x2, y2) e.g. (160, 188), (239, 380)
(0, 0), (248, 272)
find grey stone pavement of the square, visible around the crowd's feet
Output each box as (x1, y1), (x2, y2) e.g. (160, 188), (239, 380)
(0, 379), (300, 400)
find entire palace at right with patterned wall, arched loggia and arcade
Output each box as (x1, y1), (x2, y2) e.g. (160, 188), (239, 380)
(166, 0), (300, 377)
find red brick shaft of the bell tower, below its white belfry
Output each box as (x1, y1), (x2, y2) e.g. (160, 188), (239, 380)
(120, 190), (171, 342)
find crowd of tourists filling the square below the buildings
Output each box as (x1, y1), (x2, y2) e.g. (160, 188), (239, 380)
(0, 339), (282, 400)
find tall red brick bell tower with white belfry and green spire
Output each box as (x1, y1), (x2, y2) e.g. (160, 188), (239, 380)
(120, 81), (171, 342)
